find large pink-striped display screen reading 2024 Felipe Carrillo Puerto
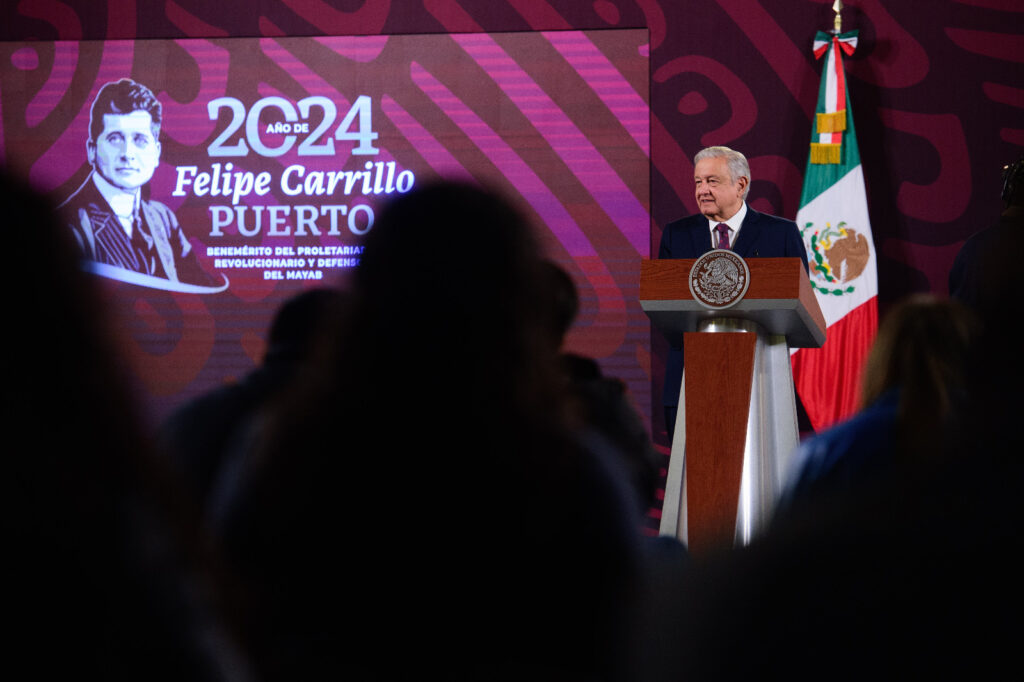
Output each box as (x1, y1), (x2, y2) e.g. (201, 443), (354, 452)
(0, 30), (650, 421)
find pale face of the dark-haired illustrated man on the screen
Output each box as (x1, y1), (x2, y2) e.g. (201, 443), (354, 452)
(86, 112), (160, 191)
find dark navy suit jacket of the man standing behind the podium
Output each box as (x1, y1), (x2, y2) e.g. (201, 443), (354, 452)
(657, 206), (807, 407)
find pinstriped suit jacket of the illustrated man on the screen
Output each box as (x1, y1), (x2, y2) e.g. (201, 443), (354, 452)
(58, 175), (208, 284)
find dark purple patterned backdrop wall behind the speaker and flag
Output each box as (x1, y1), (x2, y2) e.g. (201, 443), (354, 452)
(0, 0), (1024, 296)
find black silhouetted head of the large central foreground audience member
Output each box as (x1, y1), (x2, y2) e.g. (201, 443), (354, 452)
(352, 182), (556, 405)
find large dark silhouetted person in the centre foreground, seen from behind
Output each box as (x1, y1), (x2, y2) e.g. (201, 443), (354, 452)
(222, 183), (638, 680)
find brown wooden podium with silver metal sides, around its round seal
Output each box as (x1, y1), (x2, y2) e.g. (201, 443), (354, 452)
(640, 258), (825, 554)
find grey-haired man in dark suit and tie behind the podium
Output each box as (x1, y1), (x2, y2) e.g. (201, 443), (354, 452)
(657, 146), (807, 439)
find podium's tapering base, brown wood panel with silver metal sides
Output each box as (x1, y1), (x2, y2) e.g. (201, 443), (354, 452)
(660, 318), (799, 554)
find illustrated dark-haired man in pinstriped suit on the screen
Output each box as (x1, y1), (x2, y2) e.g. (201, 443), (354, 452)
(58, 78), (209, 285)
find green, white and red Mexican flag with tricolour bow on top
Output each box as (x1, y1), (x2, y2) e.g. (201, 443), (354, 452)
(793, 31), (879, 431)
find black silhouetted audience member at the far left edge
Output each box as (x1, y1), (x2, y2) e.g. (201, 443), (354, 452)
(0, 166), (250, 680)
